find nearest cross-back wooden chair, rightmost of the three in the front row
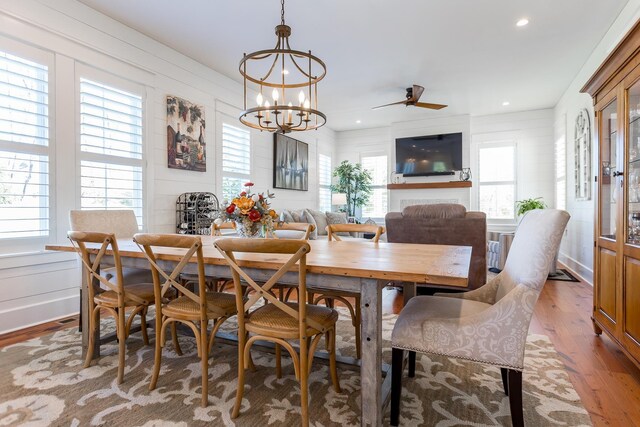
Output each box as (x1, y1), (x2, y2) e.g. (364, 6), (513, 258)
(214, 239), (340, 426)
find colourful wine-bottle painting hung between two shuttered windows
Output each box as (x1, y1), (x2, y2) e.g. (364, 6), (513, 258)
(167, 95), (207, 172)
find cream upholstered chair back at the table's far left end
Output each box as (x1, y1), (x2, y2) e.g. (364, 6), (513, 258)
(69, 209), (140, 239)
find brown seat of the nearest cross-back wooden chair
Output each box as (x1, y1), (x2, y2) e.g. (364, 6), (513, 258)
(245, 303), (338, 338)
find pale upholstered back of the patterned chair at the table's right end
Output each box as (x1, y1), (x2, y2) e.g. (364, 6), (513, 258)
(496, 209), (570, 301)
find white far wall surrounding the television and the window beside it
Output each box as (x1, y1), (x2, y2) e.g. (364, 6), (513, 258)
(336, 109), (555, 230)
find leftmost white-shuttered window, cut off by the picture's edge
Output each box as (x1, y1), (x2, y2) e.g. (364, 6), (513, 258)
(0, 51), (49, 239)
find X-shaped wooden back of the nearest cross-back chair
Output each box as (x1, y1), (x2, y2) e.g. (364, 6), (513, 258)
(214, 238), (323, 336)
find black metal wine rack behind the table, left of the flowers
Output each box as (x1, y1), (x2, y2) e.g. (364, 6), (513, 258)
(176, 193), (220, 235)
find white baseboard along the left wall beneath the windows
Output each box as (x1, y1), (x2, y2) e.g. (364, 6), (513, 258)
(0, 295), (79, 334)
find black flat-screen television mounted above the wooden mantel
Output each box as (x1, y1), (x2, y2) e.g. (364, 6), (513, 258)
(396, 133), (462, 176)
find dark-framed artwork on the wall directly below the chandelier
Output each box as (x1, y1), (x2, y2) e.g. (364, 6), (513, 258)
(273, 133), (309, 191)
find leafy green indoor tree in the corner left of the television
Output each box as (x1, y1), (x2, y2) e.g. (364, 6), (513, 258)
(331, 160), (373, 216)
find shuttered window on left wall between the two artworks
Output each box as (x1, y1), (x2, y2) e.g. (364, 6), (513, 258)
(222, 123), (251, 200)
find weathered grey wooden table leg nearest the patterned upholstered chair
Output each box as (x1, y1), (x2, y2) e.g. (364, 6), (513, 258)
(360, 279), (384, 426)
